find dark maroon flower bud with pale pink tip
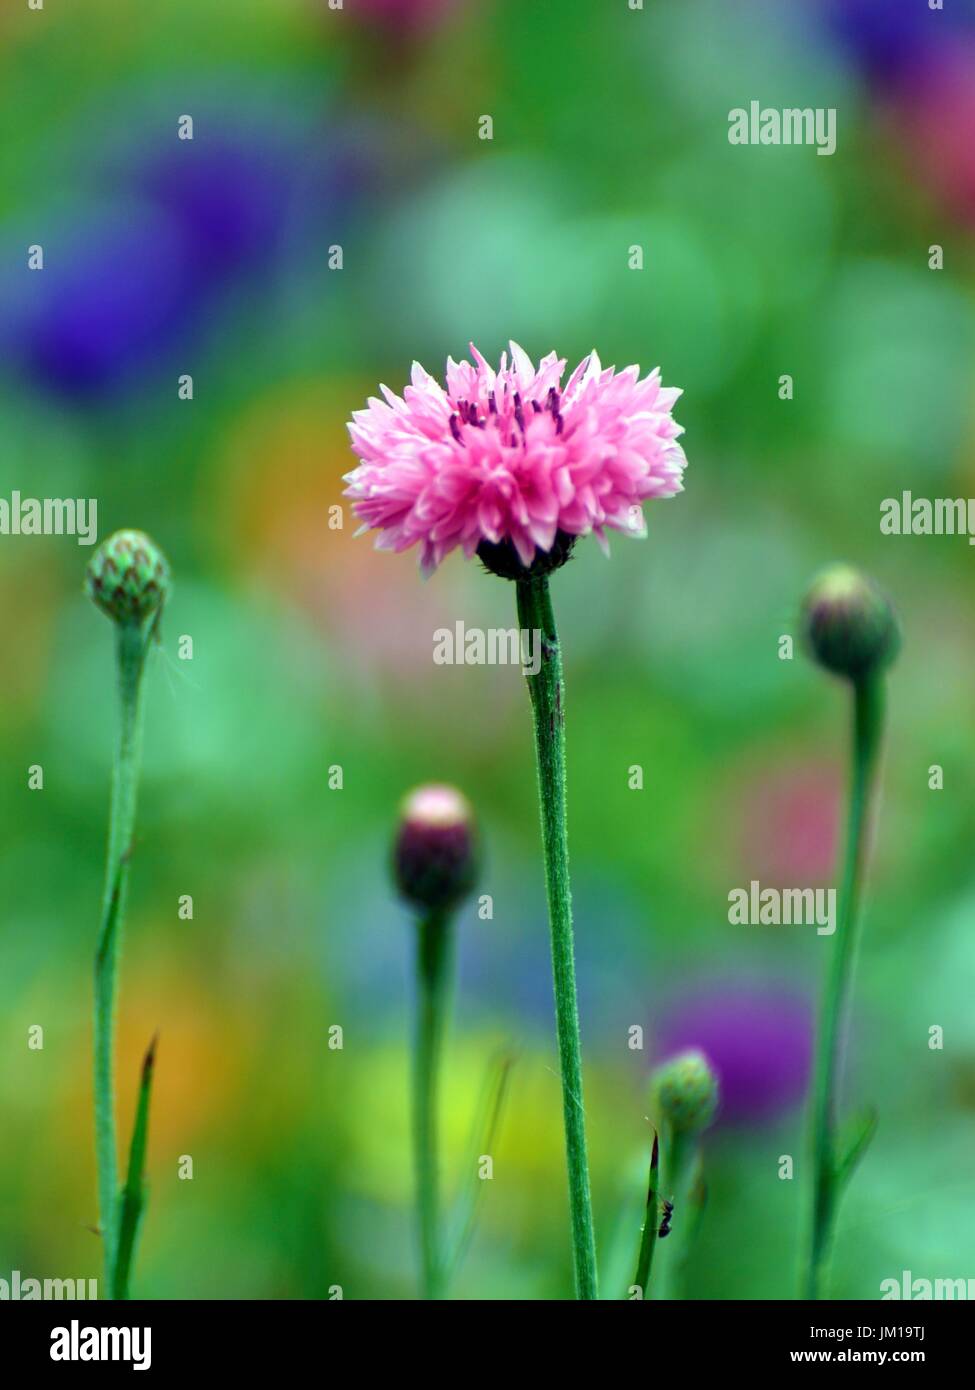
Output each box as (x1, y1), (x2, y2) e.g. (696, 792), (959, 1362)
(394, 785), (478, 912)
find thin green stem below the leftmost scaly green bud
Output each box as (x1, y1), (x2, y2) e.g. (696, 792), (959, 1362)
(95, 623), (154, 1293)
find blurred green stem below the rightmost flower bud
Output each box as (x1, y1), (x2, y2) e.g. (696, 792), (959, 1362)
(805, 677), (883, 1298)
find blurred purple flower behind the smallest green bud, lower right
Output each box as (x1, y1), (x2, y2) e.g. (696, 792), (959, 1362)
(658, 981), (812, 1125)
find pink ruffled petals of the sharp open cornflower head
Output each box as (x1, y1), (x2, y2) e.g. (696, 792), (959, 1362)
(346, 343), (686, 573)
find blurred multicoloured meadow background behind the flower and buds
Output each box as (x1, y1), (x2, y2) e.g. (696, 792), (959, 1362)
(0, 0), (975, 1298)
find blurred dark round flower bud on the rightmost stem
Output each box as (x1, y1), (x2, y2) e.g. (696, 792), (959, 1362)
(803, 564), (900, 681)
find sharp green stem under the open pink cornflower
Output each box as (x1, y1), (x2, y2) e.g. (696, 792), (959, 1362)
(516, 577), (598, 1298)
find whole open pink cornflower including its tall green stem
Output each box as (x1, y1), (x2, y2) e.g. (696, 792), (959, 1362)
(345, 343), (686, 1300)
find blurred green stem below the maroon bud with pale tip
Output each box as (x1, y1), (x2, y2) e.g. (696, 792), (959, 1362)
(413, 912), (453, 1300)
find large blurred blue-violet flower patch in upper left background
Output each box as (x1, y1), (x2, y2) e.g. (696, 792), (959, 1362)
(0, 108), (369, 399)
